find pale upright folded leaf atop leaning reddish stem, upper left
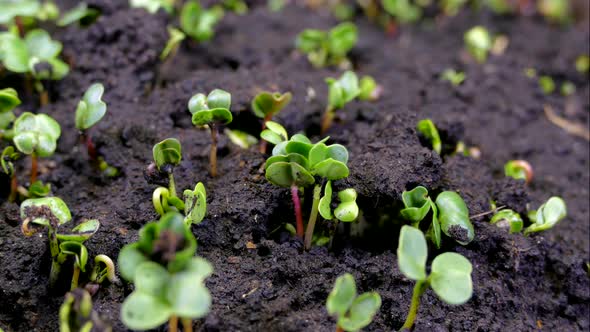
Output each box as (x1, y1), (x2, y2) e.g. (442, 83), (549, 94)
(76, 83), (107, 130)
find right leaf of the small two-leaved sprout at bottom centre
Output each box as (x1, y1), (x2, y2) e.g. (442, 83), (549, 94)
(338, 292), (381, 331)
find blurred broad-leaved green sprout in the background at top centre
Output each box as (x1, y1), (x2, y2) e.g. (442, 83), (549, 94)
(295, 22), (358, 67)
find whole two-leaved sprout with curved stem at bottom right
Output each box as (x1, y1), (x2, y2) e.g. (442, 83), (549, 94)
(397, 225), (473, 330)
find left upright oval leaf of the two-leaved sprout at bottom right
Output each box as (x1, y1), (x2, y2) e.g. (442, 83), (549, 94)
(397, 225), (428, 281)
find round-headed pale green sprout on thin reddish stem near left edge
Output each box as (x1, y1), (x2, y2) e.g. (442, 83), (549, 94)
(12, 112), (61, 183)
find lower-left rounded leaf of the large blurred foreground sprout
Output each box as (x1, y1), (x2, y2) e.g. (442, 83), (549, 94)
(121, 291), (172, 330)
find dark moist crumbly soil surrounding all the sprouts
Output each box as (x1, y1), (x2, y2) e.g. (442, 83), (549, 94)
(0, 0), (590, 331)
